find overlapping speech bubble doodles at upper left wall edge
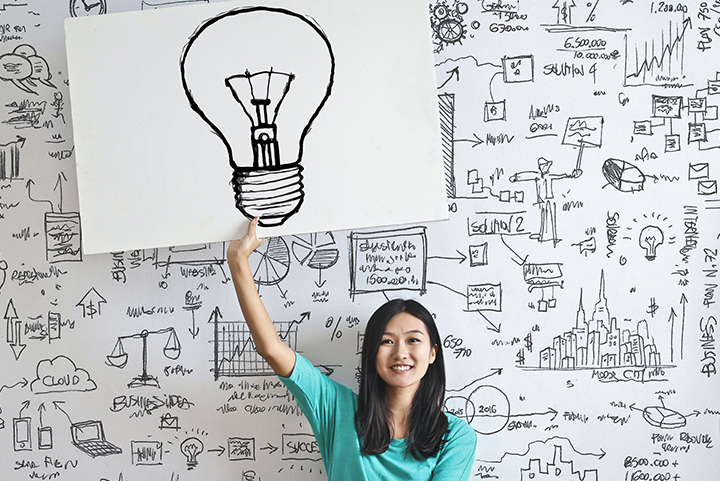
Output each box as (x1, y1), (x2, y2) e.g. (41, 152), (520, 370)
(0, 44), (57, 95)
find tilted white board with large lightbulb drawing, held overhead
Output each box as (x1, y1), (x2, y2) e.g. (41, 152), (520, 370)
(65, 0), (447, 254)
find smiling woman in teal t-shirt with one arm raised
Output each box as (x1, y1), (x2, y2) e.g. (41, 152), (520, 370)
(227, 219), (476, 481)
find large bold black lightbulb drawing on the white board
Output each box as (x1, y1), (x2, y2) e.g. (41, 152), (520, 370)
(180, 7), (335, 227)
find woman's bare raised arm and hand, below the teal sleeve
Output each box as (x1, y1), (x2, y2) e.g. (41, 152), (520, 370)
(227, 218), (295, 377)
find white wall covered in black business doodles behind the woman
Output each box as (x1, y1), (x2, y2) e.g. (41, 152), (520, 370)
(0, 0), (720, 481)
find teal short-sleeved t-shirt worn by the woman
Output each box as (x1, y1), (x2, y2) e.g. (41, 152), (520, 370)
(280, 354), (477, 481)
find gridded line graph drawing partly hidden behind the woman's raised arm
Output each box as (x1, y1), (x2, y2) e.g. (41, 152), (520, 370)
(213, 313), (310, 381)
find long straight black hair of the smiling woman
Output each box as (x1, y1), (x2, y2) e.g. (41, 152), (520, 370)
(355, 299), (448, 460)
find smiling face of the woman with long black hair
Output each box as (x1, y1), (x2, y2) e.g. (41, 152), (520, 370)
(375, 312), (437, 393)
